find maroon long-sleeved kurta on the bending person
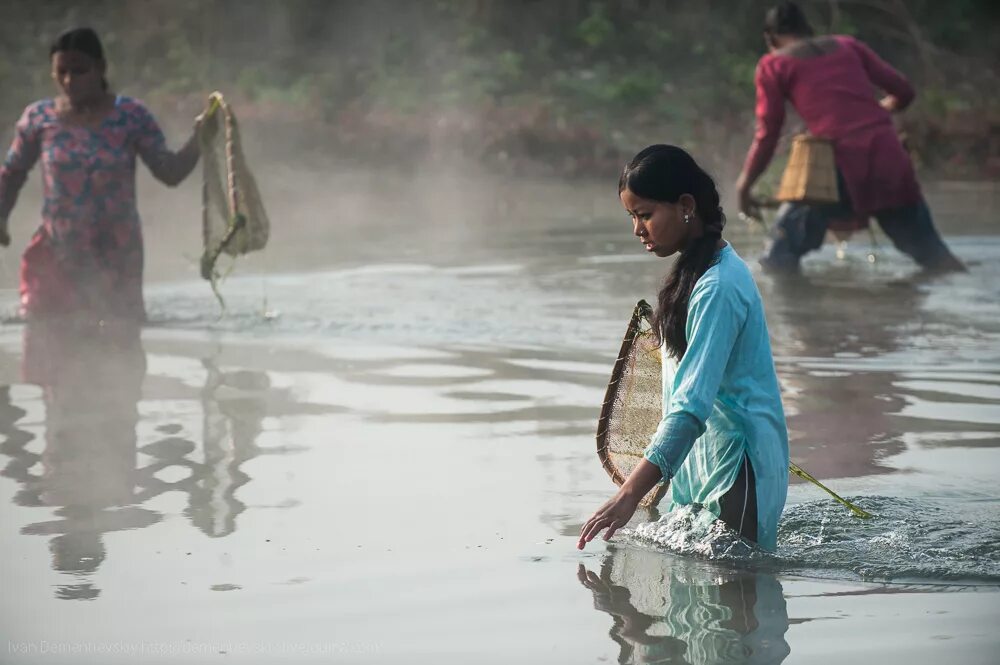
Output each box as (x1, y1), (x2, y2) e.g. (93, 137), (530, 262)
(744, 36), (921, 216)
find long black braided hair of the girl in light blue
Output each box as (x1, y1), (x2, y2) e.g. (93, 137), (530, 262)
(618, 145), (726, 359)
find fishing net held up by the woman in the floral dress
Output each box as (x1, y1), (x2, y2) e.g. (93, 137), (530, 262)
(198, 92), (271, 304)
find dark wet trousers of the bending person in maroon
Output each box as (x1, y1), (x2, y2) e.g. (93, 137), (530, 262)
(760, 199), (965, 272)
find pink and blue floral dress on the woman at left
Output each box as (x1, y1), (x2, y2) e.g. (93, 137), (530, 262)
(0, 96), (167, 319)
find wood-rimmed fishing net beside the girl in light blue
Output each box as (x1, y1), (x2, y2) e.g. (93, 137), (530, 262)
(597, 300), (667, 506)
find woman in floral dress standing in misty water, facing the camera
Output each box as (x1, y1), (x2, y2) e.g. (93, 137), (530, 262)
(0, 28), (200, 321)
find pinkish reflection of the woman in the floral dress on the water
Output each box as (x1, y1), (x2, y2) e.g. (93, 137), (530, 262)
(3, 322), (148, 600)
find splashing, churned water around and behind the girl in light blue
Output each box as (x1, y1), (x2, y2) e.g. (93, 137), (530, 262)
(621, 496), (1000, 586)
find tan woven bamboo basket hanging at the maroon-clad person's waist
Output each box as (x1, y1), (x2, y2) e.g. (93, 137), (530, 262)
(774, 134), (840, 203)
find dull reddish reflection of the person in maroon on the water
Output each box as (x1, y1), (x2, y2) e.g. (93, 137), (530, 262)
(762, 277), (924, 478)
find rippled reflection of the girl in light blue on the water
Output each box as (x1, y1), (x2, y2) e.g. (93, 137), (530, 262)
(577, 547), (790, 665)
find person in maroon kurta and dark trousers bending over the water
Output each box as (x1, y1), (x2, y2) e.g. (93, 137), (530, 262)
(736, 2), (965, 272)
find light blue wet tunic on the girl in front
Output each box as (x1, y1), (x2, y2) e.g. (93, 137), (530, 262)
(646, 245), (788, 551)
